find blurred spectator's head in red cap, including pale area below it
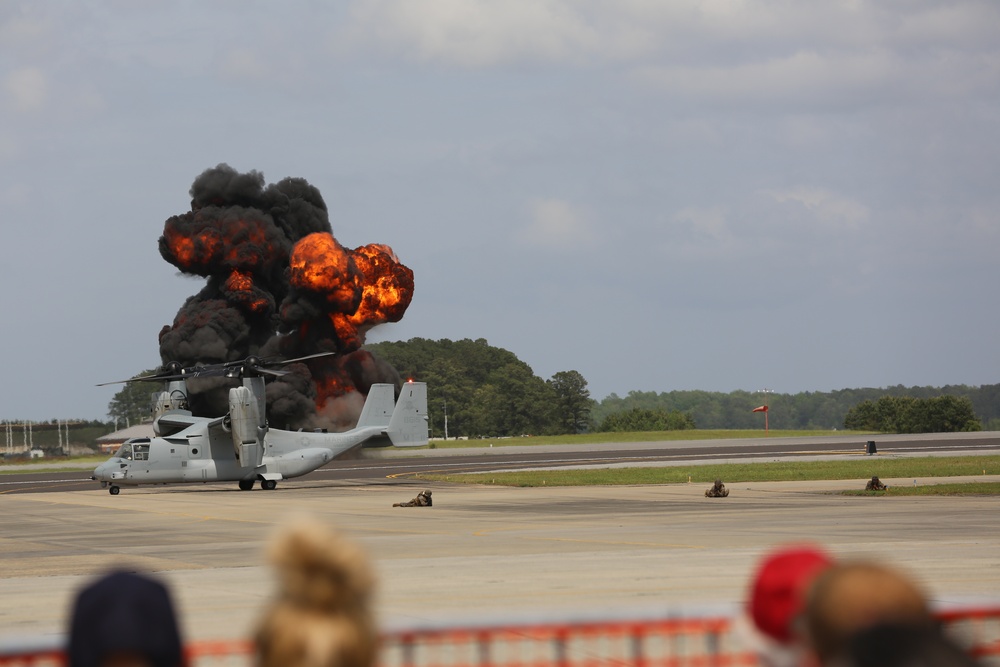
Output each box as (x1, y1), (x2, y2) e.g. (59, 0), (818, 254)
(738, 545), (833, 667)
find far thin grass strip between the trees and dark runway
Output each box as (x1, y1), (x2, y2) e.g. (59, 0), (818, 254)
(424, 429), (871, 449)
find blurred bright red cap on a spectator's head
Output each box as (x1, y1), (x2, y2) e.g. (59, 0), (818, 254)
(747, 546), (833, 644)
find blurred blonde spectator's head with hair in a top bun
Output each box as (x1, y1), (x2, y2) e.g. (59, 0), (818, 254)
(254, 520), (377, 667)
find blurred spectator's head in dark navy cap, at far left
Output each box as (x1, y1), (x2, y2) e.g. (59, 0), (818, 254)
(67, 572), (184, 667)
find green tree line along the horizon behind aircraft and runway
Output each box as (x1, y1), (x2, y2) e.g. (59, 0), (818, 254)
(108, 338), (1000, 438)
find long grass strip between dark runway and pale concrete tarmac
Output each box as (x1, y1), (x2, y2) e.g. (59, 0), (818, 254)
(415, 455), (1000, 486)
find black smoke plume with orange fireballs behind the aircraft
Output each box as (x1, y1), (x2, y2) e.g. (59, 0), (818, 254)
(160, 164), (413, 430)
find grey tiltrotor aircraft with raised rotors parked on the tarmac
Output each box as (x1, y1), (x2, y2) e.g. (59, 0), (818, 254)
(91, 353), (428, 495)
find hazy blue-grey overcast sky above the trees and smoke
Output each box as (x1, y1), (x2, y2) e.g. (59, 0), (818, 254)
(0, 0), (1000, 419)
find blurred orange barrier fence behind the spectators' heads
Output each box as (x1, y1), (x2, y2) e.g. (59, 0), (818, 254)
(0, 607), (1000, 667)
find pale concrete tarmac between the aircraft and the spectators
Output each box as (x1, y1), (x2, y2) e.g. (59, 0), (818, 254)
(0, 476), (1000, 640)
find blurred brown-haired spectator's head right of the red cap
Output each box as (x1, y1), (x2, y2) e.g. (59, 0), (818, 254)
(806, 561), (937, 666)
